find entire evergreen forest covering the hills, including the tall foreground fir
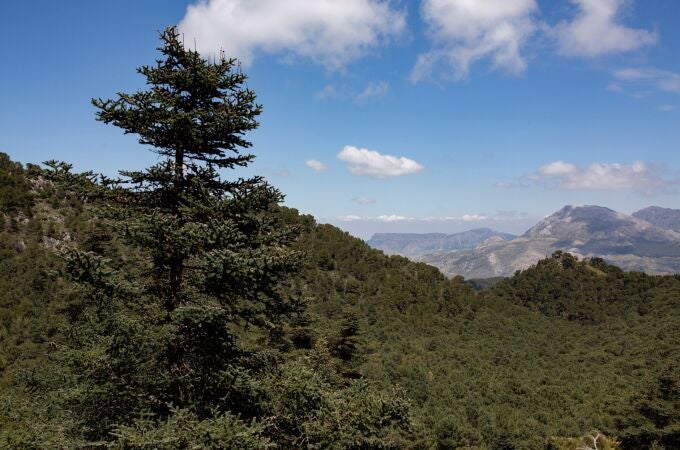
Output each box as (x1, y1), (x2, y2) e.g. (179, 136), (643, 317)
(0, 28), (680, 450)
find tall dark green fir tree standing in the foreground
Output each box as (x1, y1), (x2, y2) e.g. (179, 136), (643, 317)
(49, 27), (301, 440)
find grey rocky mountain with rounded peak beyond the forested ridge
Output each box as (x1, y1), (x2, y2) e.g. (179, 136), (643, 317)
(418, 206), (680, 278)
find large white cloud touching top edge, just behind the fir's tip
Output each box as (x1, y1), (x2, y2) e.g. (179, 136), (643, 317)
(179, 0), (406, 69)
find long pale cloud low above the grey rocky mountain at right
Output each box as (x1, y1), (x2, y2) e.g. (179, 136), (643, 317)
(525, 161), (677, 194)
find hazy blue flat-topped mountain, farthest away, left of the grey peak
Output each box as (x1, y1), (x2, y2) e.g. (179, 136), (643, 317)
(368, 228), (516, 257)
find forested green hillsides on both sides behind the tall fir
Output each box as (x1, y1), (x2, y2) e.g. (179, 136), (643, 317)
(0, 154), (680, 449)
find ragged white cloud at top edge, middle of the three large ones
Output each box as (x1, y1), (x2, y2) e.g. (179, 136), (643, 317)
(411, 0), (538, 82)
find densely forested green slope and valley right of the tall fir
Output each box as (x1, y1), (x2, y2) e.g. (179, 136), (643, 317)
(286, 236), (680, 449)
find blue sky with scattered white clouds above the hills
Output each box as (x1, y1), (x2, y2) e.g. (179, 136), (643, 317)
(0, 0), (680, 237)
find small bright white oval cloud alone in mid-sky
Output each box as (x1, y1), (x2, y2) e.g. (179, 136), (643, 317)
(338, 145), (424, 178)
